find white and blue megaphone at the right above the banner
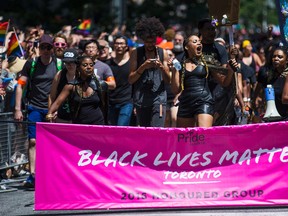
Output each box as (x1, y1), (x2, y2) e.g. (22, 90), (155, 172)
(263, 85), (283, 122)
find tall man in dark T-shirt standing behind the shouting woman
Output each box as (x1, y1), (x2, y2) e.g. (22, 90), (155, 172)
(198, 18), (236, 125)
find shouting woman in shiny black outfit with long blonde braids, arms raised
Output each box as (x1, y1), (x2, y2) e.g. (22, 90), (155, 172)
(168, 35), (237, 127)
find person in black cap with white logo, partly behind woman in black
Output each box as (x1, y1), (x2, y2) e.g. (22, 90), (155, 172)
(49, 48), (78, 123)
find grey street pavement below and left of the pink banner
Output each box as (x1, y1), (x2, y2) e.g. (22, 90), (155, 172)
(0, 176), (288, 216)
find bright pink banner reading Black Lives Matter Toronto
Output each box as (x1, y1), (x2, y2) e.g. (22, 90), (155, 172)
(35, 122), (288, 210)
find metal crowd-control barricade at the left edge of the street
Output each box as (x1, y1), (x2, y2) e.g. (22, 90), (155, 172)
(0, 112), (28, 170)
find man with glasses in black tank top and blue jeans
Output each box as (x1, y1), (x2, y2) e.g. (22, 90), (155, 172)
(107, 35), (133, 126)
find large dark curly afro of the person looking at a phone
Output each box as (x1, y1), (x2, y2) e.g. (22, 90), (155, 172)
(135, 17), (165, 40)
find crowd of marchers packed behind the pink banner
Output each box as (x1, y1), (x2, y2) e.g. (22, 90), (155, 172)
(0, 17), (288, 187)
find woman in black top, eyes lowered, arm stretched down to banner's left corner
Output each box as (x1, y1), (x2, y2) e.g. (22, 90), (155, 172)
(46, 56), (104, 125)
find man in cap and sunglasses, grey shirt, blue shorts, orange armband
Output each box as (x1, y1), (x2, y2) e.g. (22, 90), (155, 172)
(14, 34), (57, 188)
